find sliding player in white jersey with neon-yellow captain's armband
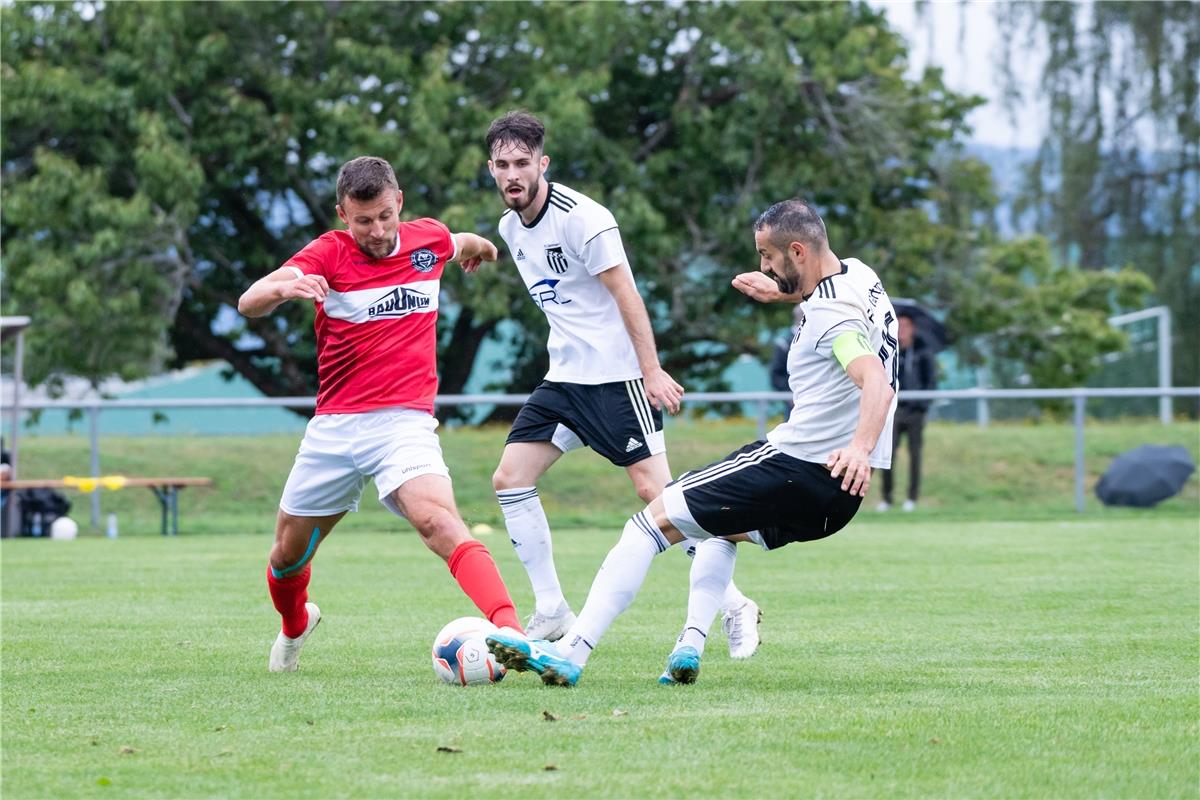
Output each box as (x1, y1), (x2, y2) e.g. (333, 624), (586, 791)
(487, 199), (898, 686)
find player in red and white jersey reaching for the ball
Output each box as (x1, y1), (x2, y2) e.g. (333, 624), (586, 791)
(238, 156), (521, 672)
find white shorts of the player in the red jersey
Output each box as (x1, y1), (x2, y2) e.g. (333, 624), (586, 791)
(280, 408), (450, 517)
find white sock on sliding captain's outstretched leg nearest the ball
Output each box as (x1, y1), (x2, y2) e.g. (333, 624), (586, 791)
(558, 511), (671, 667)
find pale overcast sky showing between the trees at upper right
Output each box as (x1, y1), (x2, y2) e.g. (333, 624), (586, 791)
(870, 0), (1044, 148)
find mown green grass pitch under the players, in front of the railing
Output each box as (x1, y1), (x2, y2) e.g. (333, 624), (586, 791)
(0, 515), (1200, 799)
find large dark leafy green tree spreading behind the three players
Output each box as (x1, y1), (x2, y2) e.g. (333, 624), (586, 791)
(0, 2), (1147, 407)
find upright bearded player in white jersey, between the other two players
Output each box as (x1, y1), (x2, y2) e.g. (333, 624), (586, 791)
(487, 112), (758, 657)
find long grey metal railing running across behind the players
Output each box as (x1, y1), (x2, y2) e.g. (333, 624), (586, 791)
(4, 386), (1200, 529)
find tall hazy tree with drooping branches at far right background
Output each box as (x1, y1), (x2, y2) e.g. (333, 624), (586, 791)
(996, 1), (1200, 385)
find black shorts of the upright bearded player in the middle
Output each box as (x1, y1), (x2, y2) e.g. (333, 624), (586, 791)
(508, 378), (666, 467)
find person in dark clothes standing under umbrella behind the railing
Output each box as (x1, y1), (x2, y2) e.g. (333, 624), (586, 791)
(875, 313), (937, 511)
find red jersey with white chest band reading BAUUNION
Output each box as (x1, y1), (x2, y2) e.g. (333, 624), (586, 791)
(284, 218), (456, 414)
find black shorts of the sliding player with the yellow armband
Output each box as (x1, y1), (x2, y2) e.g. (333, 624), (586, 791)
(662, 441), (863, 549)
